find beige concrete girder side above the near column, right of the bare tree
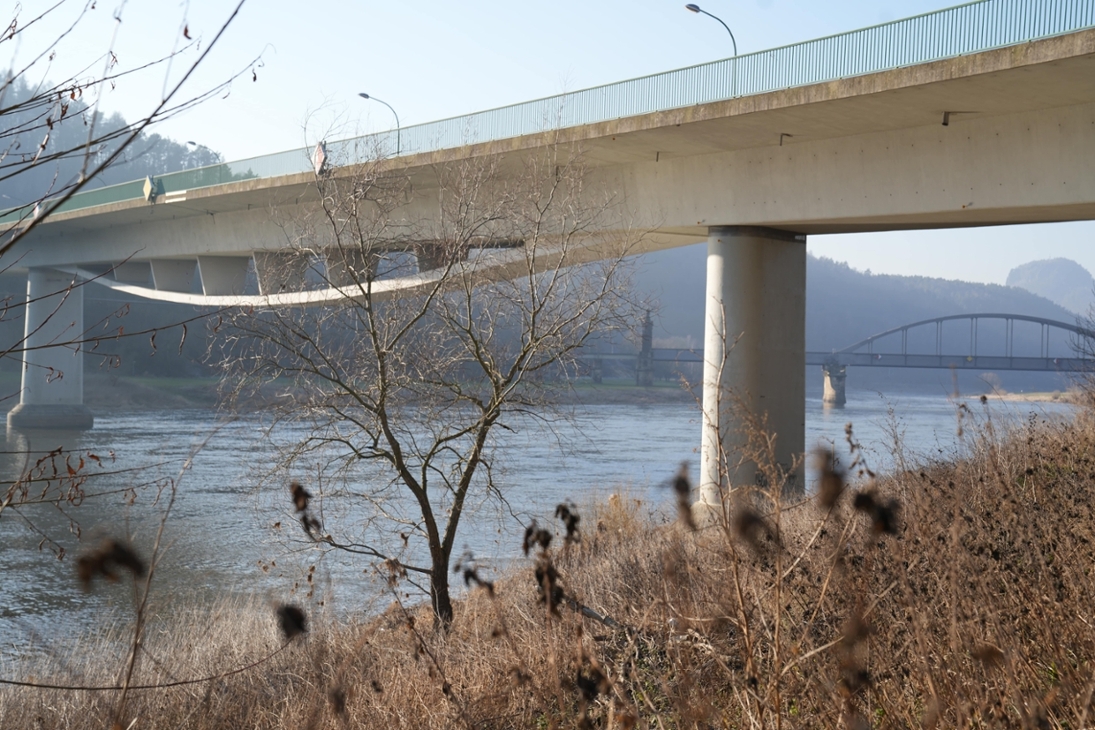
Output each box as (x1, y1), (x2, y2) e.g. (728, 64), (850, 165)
(590, 99), (1095, 235)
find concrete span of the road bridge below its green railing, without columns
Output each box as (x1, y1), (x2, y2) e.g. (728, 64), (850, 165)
(13, 28), (1095, 271)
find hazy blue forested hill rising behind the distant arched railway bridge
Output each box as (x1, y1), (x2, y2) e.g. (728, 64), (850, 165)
(636, 244), (1075, 350)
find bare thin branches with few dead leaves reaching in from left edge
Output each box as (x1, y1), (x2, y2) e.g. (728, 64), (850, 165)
(0, 0), (260, 556)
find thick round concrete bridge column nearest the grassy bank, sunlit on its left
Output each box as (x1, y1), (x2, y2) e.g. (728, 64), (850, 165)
(700, 225), (806, 507)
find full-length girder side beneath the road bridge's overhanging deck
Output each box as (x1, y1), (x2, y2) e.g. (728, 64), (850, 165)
(14, 98), (1095, 275)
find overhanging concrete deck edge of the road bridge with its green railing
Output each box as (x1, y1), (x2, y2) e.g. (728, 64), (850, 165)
(0, 0), (1095, 234)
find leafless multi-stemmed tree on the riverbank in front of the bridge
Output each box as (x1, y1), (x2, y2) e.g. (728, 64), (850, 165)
(223, 144), (641, 627)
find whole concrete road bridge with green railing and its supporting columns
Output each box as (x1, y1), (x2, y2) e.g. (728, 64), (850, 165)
(0, 0), (1095, 502)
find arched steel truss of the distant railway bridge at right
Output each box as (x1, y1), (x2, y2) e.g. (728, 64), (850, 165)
(807, 312), (1095, 372)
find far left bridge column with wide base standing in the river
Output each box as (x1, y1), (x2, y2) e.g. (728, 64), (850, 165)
(8, 268), (94, 430)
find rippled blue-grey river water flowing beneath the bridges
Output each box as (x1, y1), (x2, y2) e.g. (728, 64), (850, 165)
(0, 392), (1070, 653)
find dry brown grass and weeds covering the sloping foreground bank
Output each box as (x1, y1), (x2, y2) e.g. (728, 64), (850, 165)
(0, 402), (1095, 729)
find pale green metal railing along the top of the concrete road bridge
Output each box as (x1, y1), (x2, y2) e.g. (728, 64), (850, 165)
(0, 0), (1095, 223)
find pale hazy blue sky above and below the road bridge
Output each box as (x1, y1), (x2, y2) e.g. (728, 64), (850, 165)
(10, 0), (1095, 283)
